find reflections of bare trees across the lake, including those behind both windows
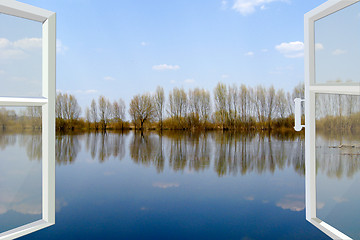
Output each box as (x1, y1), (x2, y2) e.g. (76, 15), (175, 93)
(0, 131), (360, 178)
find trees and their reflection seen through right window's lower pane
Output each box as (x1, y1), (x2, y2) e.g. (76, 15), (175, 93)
(316, 94), (360, 178)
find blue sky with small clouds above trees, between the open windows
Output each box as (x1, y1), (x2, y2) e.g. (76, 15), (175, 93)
(0, 0), (325, 113)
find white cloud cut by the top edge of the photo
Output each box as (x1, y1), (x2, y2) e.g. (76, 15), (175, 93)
(232, 0), (286, 16)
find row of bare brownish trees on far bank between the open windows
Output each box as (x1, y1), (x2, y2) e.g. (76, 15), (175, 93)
(56, 83), (304, 131)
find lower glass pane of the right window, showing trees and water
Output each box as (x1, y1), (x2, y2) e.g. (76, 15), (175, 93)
(316, 94), (360, 239)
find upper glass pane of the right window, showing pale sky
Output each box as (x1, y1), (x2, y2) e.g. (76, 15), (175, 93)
(315, 2), (360, 85)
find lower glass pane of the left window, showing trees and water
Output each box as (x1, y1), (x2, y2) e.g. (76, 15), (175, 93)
(0, 107), (42, 233)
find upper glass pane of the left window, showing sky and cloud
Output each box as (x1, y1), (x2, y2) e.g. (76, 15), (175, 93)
(0, 14), (42, 97)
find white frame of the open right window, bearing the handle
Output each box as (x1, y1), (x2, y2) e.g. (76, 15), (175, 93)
(304, 0), (360, 239)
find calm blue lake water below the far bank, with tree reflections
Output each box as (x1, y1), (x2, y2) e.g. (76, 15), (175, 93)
(0, 132), (352, 240)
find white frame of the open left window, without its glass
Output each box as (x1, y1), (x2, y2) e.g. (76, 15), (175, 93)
(0, 0), (56, 240)
